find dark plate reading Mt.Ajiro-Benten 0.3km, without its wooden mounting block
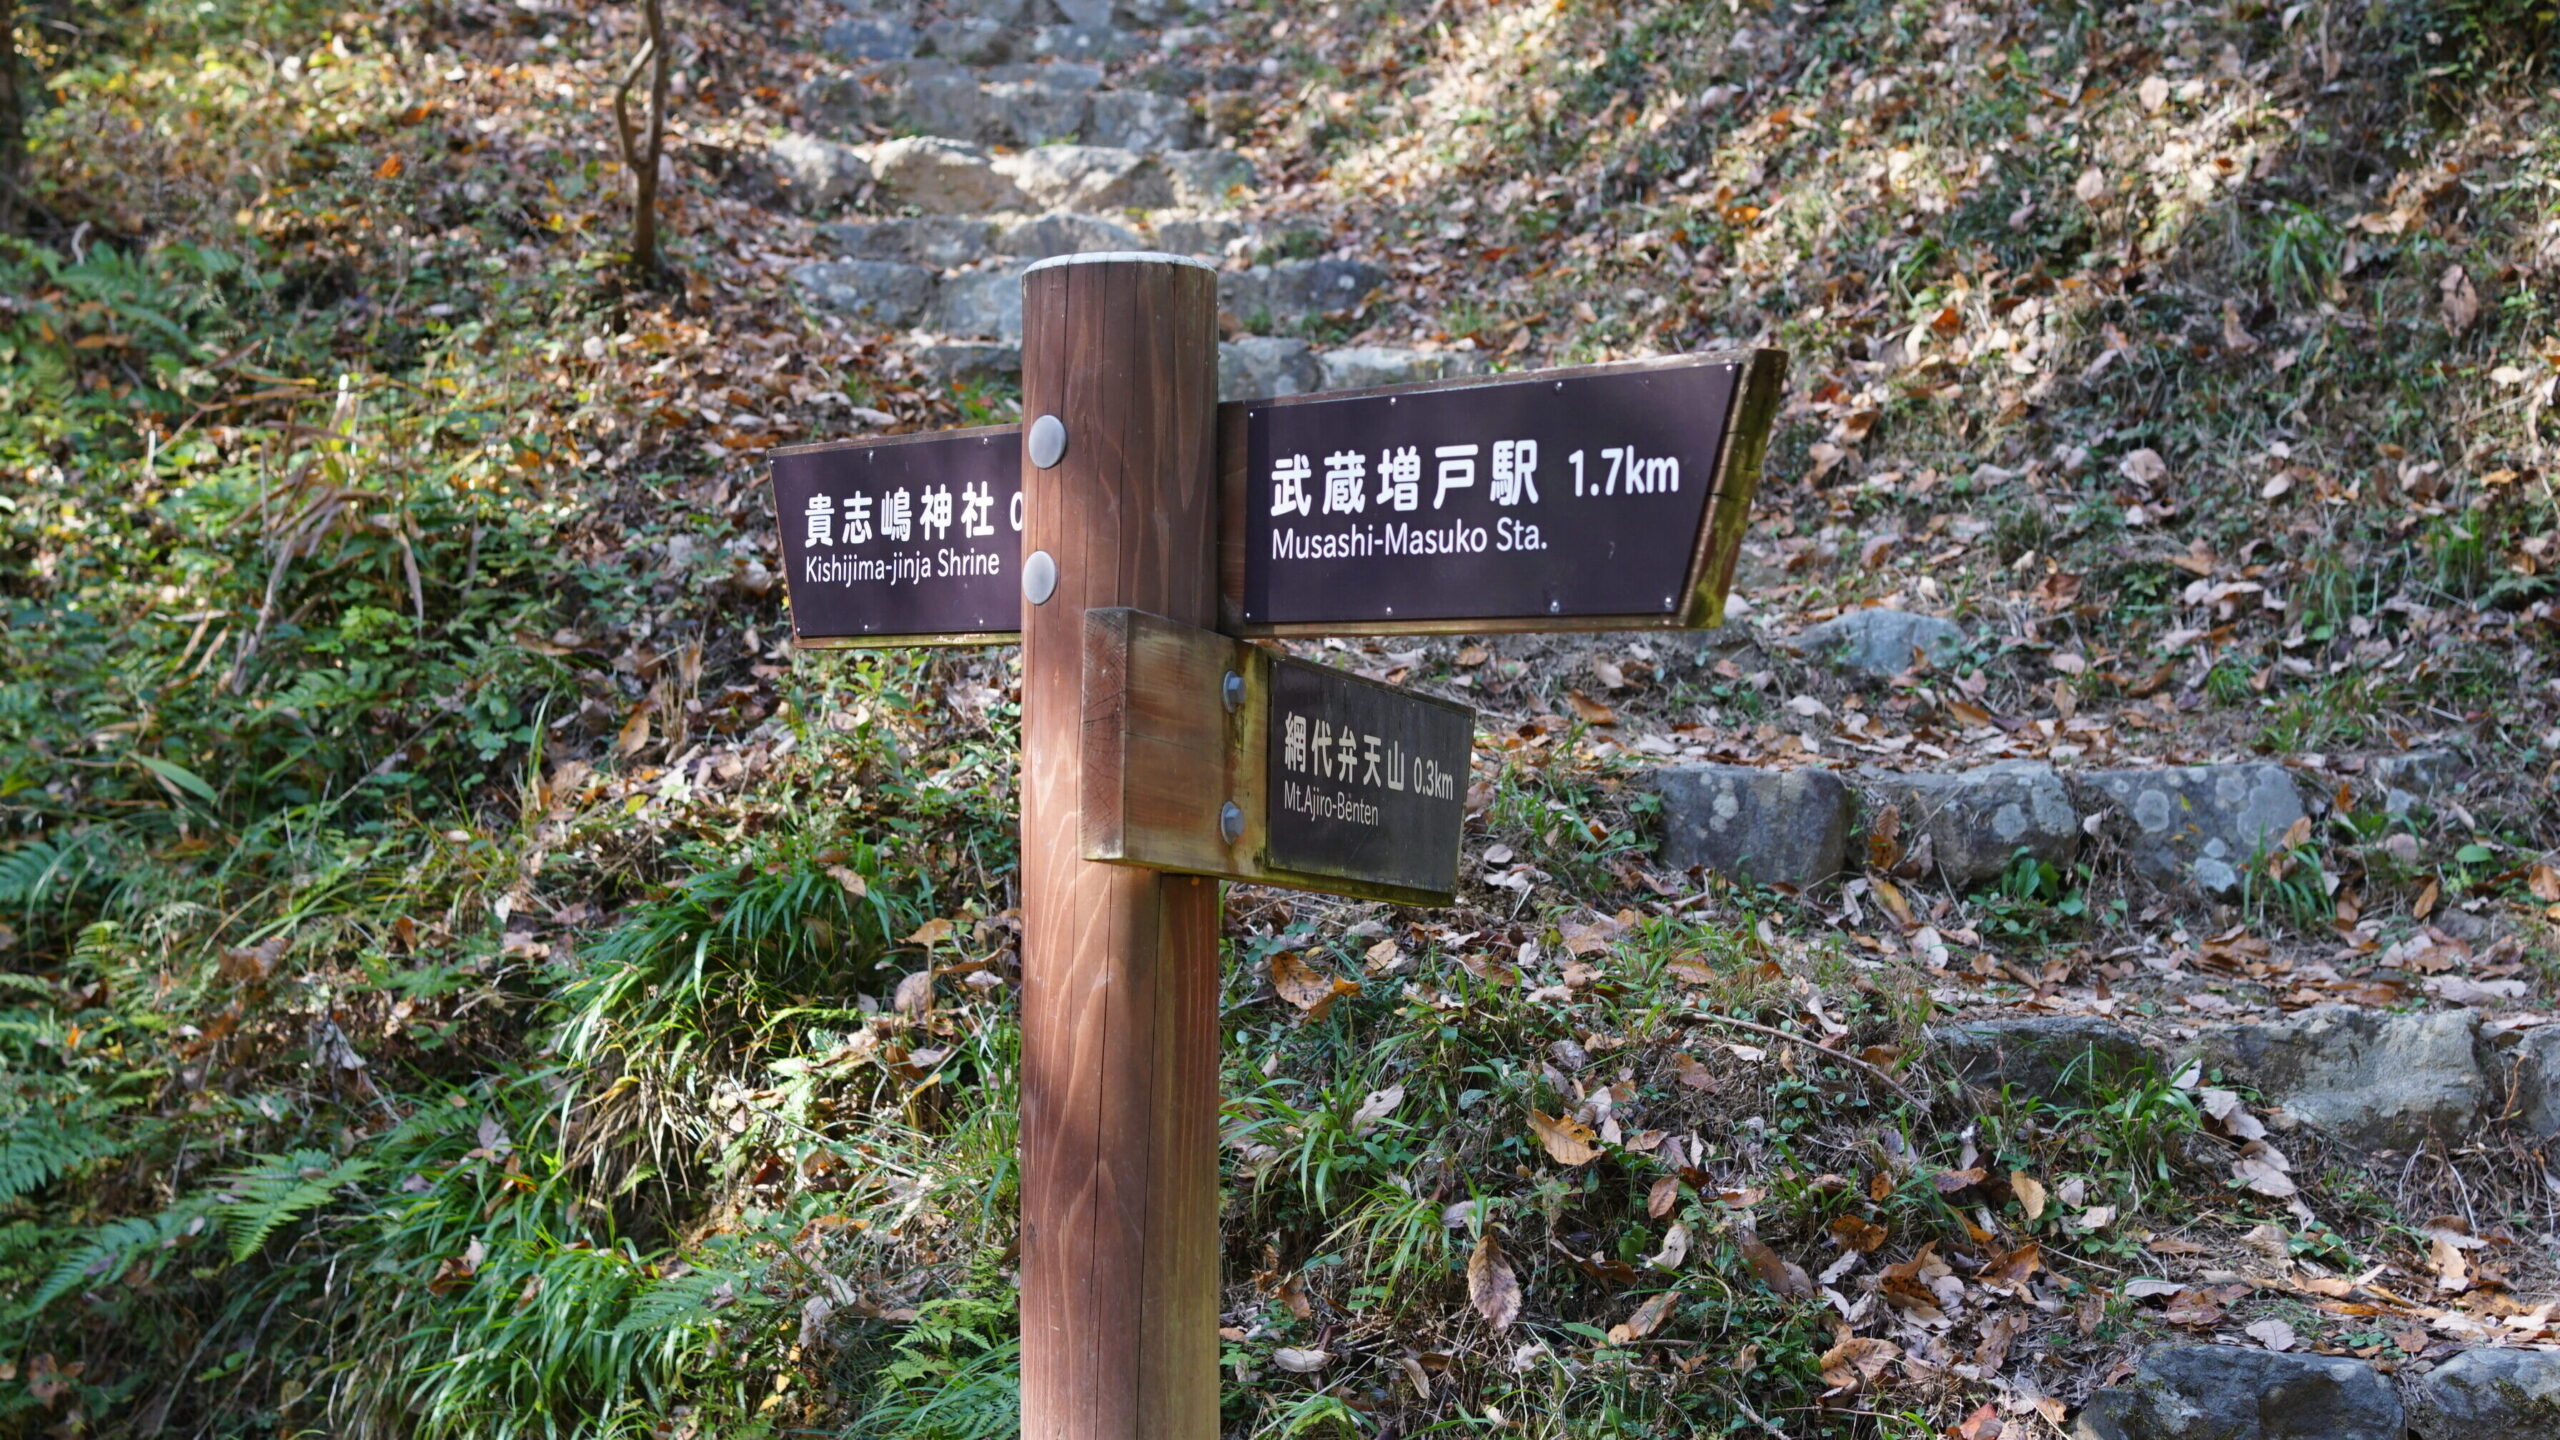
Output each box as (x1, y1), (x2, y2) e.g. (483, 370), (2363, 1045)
(1265, 659), (1475, 894)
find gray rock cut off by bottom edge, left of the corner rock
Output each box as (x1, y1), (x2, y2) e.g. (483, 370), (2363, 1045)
(2071, 1345), (2406, 1440)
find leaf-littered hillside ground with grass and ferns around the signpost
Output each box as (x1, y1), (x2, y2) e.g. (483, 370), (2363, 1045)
(0, 0), (2560, 1440)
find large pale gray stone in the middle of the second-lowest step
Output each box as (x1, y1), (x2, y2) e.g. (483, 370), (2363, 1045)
(2191, 1004), (2488, 1150)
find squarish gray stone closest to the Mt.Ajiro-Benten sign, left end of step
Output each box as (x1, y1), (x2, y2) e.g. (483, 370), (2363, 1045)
(1654, 766), (1851, 889)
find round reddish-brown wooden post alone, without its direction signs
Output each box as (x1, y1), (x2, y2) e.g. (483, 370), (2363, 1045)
(1021, 254), (1219, 1440)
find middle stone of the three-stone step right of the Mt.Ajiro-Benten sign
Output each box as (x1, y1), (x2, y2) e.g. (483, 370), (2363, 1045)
(1859, 761), (2081, 889)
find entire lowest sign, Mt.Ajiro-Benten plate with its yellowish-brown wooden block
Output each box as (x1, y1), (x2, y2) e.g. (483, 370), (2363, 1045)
(1083, 610), (1475, 904)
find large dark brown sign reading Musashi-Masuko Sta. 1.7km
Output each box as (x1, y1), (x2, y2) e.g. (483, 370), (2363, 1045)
(1219, 351), (1784, 635)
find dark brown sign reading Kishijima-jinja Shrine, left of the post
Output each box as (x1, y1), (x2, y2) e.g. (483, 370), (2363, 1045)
(773, 425), (1021, 648)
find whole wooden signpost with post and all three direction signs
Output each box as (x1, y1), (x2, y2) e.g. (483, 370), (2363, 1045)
(773, 254), (1784, 1440)
